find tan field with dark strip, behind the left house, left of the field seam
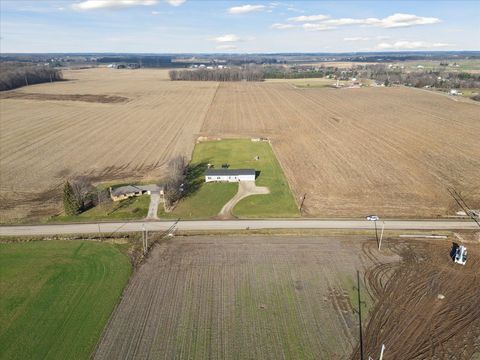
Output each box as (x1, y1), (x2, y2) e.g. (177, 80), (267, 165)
(0, 69), (217, 222)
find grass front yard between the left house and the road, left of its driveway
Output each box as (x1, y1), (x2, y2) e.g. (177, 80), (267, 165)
(47, 195), (150, 223)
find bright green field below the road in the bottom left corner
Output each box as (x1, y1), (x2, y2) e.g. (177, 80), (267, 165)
(0, 241), (131, 359)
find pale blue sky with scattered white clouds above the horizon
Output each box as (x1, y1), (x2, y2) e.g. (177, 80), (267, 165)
(0, 0), (480, 53)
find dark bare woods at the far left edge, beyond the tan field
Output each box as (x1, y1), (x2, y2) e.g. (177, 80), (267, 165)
(0, 63), (63, 91)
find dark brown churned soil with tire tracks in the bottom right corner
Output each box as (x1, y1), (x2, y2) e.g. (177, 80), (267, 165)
(352, 241), (480, 360)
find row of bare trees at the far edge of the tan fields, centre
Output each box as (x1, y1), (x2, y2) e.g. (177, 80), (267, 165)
(168, 67), (265, 81)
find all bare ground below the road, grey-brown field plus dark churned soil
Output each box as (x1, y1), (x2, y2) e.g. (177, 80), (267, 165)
(94, 236), (480, 360)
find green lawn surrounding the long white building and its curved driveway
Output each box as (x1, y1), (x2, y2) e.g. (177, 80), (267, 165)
(159, 139), (299, 218)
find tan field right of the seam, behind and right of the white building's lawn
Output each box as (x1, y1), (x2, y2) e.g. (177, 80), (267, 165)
(202, 83), (480, 217)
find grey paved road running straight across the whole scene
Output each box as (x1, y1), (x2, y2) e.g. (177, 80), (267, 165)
(0, 219), (480, 236)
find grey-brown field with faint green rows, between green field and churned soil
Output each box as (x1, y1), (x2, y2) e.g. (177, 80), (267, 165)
(94, 236), (398, 359)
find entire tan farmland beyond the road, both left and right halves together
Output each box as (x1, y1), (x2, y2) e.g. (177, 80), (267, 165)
(0, 69), (480, 222)
